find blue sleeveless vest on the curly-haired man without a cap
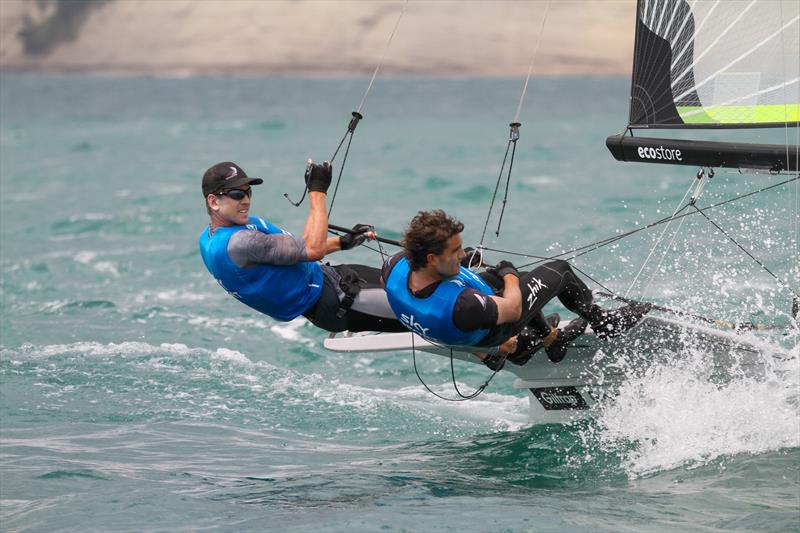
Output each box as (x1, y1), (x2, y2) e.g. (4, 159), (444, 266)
(386, 257), (494, 346)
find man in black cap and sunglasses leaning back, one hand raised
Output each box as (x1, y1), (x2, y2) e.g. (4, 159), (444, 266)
(195, 160), (404, 331)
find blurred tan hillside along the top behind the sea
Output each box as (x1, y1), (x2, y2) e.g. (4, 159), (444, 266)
(0, 0), (635, 76)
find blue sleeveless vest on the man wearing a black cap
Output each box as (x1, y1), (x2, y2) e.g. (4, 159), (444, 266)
(200, 217), (323, 321)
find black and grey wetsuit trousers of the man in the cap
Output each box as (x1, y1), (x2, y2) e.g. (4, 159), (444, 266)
(303, 265), (408, 332)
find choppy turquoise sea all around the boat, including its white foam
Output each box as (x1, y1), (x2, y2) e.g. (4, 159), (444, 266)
(0, 74), (800, 532)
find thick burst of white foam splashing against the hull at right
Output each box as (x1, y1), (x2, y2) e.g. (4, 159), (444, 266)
(597, 344), (800, 477)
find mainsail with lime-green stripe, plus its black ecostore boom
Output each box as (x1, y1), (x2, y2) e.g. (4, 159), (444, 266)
(606, 0), (800, 171)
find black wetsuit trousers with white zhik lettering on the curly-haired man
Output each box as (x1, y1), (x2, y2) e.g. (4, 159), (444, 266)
(479, 260), (596, 346)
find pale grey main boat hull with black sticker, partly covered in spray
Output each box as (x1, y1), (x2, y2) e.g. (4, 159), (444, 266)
(509, 316), (789, 423)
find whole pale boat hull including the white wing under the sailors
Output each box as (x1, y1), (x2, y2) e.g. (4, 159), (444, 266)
(325, 315), (789, 424)
